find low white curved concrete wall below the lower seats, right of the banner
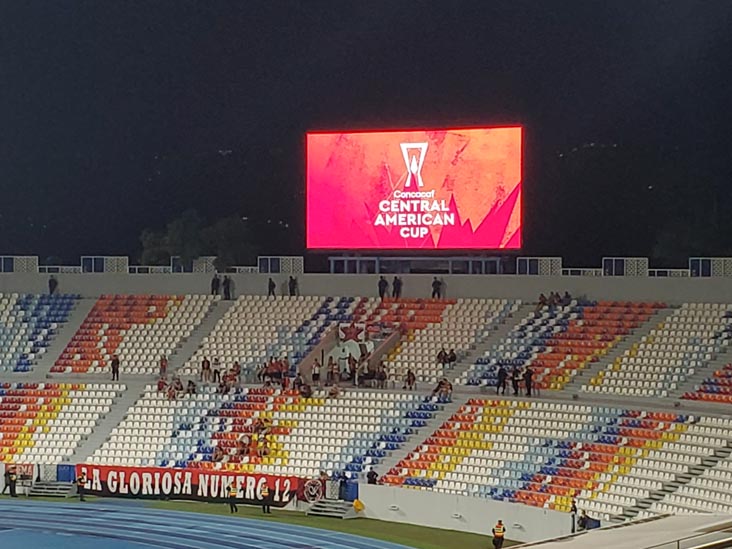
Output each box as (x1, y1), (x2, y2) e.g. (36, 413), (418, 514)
(359, 484), (572, 546)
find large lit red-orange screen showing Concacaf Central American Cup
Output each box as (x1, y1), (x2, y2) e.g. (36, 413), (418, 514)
(307, 127), (522, 250)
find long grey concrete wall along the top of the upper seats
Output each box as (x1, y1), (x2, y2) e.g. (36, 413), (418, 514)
(0, 273), (732, 303)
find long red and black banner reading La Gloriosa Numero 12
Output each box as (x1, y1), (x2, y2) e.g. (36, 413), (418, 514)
(76, 464), (302, 507)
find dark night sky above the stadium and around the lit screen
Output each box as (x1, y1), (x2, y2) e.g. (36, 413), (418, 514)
(0, 0), (732, 261)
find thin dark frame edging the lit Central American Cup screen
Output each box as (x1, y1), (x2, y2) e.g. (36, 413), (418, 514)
(304, 123), (526, 256)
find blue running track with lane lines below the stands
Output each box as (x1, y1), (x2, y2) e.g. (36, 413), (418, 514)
(0, 500), (418, 549)
